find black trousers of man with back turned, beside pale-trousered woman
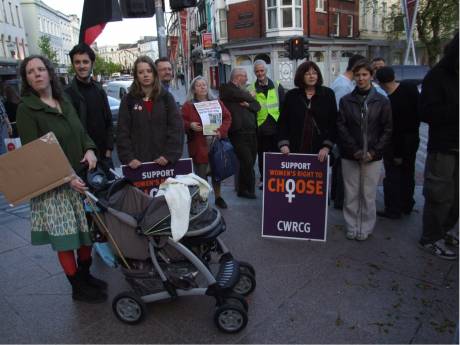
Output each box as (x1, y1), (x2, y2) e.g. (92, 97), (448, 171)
(383, 152), (416, 215)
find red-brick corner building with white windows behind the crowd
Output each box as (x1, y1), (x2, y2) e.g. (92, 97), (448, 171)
(181, 0), (368, 88)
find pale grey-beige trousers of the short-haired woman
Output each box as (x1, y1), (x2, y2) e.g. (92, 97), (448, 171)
(342, 159), (382, 235)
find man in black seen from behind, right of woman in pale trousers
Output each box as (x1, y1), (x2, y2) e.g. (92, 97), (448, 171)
(376, 67), (420, 219)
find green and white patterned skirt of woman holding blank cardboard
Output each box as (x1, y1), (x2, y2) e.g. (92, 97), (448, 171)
(30, 184), (92, 251)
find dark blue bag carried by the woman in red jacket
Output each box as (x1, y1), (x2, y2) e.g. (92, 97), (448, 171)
(209, 139), (237, 182)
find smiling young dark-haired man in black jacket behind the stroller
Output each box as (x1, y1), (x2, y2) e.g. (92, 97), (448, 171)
(65, 43), (113, 169)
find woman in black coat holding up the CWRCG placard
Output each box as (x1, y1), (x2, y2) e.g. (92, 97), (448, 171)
(278, 61), (337, 162)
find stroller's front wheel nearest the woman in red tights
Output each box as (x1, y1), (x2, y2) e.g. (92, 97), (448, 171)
(112, 292), (145, 325)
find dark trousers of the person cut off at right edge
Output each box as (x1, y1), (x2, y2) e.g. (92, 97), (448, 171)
(420, 152), (458, 244)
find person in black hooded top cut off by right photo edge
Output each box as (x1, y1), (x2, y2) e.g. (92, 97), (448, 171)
(419, 34), (459, 260)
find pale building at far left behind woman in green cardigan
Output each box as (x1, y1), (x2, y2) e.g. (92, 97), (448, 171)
(0, 0), (29, 80)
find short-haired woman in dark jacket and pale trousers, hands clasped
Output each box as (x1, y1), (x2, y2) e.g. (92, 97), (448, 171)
(337, 60), (392, 241)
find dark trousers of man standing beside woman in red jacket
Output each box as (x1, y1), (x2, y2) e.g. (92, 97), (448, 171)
(229, 131), (257, 194)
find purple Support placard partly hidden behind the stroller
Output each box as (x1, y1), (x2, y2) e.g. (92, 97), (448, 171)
(121, 158), (193, 197)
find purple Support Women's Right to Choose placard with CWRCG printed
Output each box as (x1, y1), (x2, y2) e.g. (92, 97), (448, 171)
(262, 153), (329, 241)
